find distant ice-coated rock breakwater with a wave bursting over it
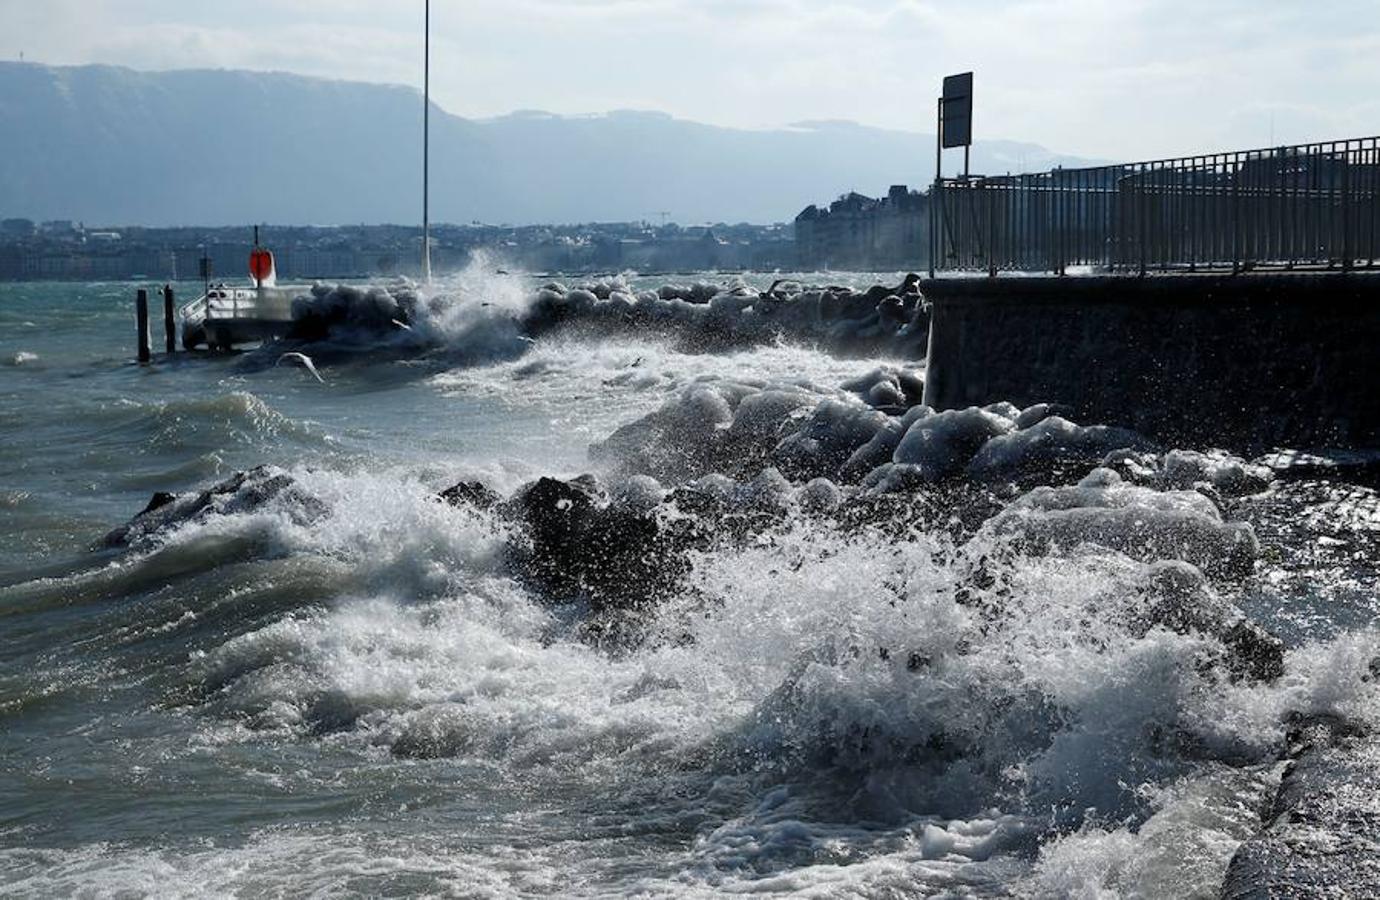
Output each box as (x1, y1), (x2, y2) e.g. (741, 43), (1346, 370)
(262, 267), (929, 364)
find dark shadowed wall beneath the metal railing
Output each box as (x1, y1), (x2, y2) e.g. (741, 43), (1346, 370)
(922, 272), (1380, 449)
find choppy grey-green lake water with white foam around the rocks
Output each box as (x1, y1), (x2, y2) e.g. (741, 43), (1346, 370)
(0, 276), (1380, 896)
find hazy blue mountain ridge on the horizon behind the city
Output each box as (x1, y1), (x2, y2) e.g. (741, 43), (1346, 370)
(0, 62), (1098, 225)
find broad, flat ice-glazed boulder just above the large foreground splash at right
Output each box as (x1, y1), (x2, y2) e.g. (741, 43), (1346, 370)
(987, 469), (1260, 576)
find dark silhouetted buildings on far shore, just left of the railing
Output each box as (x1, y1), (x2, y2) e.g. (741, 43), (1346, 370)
(795, 185), (930, 271)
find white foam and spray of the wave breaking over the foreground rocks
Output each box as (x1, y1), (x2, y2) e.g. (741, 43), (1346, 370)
(26, 438), (1376, 896)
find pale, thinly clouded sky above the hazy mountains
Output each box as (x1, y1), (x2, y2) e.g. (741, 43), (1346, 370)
(0, 0), (1380, 160)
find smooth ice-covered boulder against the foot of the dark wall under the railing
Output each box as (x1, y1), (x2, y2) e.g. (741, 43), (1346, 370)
(967, 415), (1152, 480)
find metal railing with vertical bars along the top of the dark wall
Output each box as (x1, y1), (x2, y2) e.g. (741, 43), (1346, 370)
(930, 138), (1380, 275)
